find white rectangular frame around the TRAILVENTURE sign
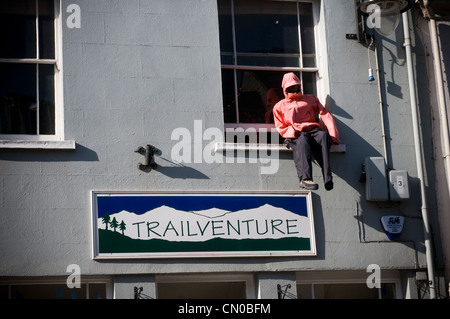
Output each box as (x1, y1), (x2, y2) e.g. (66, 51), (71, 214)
(91, 190), (317, 260)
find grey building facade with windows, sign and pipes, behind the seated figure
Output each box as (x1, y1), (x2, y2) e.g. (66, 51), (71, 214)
(0, 0), (450, 299)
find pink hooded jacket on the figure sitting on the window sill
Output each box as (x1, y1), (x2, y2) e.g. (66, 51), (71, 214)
(273, 72), (339, 144)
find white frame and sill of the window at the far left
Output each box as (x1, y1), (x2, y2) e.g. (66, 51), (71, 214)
(0, 0), (75, 149)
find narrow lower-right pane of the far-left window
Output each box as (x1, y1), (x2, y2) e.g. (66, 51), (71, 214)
(39, 65), (55, 135)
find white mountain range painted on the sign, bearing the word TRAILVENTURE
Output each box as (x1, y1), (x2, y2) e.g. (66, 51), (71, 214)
(97, 204), (311, 243)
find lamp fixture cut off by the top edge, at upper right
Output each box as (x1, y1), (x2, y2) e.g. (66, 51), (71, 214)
(358, 0), (411, 36)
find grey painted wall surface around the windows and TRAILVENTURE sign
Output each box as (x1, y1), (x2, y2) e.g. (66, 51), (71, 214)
(0, 0), (439, 282)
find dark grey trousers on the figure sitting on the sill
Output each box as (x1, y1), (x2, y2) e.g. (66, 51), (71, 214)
(288, 130), (333, 184)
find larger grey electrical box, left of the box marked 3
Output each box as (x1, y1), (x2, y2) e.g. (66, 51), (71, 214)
(364, 157), (389, 201)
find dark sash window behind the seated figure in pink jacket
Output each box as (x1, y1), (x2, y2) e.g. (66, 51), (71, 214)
(218, 0), (318, 129)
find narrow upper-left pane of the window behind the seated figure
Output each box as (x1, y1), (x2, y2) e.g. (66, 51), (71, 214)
(217, 0), (234, 64)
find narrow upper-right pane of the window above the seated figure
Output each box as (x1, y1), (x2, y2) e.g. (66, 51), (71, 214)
(299, 3), (316, 67)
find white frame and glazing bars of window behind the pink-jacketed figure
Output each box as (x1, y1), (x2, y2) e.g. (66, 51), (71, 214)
(221, 0), (329, 132)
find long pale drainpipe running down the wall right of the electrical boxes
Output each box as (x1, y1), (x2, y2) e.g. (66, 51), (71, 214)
(402, 12), (436, 299)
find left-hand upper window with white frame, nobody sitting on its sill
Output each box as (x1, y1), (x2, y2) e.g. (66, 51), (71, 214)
(0, 0), (62, 141)
